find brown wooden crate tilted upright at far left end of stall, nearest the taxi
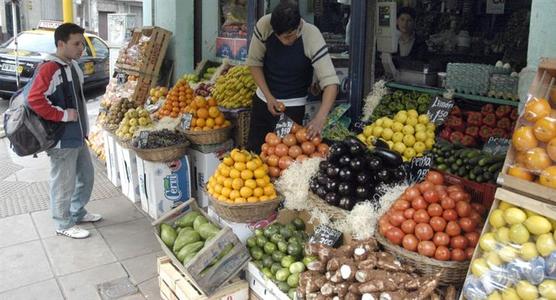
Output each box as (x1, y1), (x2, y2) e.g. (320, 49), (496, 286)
(116, 26), (172, 75)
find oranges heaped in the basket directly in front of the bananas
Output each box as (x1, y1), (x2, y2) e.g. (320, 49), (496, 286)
(185, 96), (231, 131)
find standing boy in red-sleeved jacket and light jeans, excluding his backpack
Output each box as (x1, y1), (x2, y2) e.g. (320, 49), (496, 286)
(24, 23), (102, 239)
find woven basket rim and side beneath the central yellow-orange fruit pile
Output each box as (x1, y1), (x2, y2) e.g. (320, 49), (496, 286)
(205, 191), (282, 223)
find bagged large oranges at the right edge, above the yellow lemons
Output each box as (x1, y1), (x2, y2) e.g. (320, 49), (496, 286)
(508, 97), (556, 189)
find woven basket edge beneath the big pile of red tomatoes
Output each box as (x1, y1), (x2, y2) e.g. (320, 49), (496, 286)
(375, 232), (469, 286)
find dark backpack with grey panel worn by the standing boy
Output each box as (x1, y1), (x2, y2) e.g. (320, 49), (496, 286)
(4, 62), (69, 156)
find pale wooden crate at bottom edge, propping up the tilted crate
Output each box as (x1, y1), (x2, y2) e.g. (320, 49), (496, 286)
(158, 256), (249, 300)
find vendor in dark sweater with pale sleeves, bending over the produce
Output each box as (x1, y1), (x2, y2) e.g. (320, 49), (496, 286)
(246, 1), (339, 153)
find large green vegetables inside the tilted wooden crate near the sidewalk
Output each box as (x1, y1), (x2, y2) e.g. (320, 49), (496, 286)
(160, 211), (222, 264)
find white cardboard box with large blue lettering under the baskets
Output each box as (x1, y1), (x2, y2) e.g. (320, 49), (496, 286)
(137, 156), (191, 219)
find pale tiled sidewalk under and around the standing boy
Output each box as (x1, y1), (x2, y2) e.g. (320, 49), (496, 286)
(0, 138), (163, 300)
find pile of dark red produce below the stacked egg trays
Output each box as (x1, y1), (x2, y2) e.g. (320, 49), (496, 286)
(440, 104), (518, 147)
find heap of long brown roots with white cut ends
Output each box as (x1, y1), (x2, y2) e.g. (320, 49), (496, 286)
(297, 239), (448, 300)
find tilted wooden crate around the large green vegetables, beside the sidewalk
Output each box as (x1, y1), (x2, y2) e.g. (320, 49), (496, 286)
(152, 198), (250, 296)
